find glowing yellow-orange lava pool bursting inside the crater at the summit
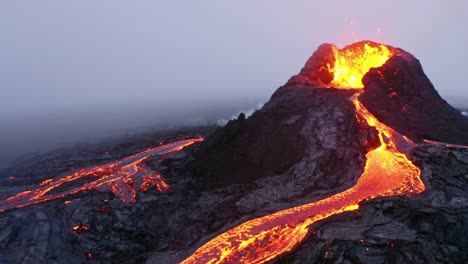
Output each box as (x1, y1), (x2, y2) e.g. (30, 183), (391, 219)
(328, 42), (394, 89)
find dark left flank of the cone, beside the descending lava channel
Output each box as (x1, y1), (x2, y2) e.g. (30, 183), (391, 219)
(190, 86), (378, 189)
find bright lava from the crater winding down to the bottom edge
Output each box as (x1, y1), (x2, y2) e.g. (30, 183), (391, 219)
(182, 43), (425, 263)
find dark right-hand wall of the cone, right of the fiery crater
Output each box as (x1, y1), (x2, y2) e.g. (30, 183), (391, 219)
(359, 49), (468, 144)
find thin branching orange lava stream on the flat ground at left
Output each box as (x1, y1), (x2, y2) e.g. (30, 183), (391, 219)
(0, 137), (203, 212)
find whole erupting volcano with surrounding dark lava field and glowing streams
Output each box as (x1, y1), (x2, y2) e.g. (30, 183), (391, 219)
(0, 41), (468, 263)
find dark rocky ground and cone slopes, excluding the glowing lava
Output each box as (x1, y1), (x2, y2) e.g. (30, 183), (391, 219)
(0, 41), (468, 263)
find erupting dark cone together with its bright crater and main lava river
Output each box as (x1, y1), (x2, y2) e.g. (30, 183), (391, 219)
(177, 41), (467, 263)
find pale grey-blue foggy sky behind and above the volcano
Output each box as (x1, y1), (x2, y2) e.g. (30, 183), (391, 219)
(0, 0), (468, 167)
